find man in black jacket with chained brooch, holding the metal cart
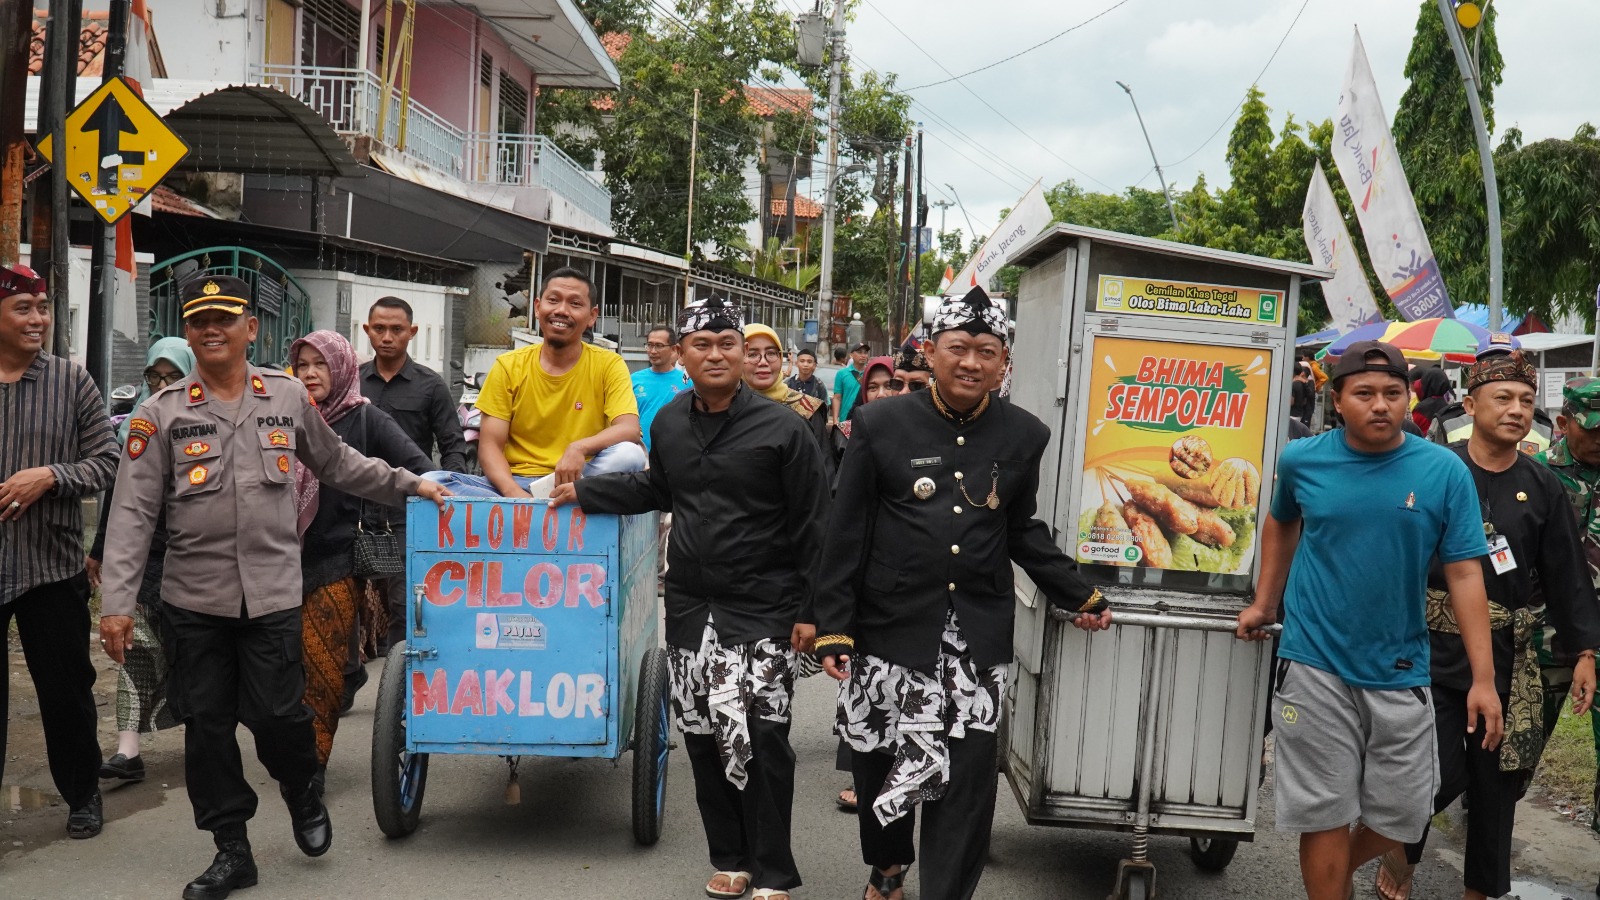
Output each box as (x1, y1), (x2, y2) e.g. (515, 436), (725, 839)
(816, 288), (1110, 900)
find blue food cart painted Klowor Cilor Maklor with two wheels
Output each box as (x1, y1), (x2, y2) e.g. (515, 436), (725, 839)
(373, 498), (670, 846)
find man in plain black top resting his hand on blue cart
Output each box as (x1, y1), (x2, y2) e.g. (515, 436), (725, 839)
(550, 299), (827, 900)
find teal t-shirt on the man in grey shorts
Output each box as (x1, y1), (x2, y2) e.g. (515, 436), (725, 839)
(1272, 428), (1488, 690)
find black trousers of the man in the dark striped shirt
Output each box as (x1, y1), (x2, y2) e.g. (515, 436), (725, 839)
(0, 573), (101, 809)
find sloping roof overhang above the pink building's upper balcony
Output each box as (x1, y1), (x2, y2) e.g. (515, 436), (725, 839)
(458, 0), (621, 90)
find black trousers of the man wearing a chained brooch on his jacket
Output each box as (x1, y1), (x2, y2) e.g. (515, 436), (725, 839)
(851, 730), (1000, 900)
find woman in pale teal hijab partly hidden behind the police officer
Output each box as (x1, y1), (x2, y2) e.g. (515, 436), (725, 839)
(85, 338), (195, 781)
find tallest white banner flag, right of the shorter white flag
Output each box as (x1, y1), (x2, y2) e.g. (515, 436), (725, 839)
(1333, 30), (1456, 322)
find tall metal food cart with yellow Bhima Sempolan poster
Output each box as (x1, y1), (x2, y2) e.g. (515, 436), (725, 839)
(1002, 224), (1331, 900)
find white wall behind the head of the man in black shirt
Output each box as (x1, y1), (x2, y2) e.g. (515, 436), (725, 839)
(293, 271), (467, 374)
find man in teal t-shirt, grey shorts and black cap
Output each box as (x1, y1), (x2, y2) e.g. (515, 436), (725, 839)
(1238, 341), (1501, 900)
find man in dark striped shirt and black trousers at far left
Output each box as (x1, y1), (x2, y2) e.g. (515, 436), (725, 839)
(0, 266), (117, 839)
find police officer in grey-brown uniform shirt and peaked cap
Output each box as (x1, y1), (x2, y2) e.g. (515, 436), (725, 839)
(101, 275), (448, 900)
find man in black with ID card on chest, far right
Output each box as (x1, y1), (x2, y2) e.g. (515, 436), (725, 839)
(1378, 335), (1600, 900)
